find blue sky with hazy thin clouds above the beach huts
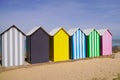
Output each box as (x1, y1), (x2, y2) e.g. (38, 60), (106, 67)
(0, 0), (120, 36)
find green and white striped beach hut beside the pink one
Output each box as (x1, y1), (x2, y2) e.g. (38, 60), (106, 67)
(83, 29), (100, 57)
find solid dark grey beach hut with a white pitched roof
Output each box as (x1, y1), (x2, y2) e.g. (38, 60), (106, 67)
(26, 27), (49, 64)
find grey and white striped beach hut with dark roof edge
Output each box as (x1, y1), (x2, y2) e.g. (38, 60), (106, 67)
(0, 25), (25, 67)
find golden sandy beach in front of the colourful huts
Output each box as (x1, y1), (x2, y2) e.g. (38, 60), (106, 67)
(0, 53), (120, 80)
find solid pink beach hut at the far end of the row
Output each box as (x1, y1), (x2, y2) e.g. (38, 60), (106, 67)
(97, 29), (112, 56)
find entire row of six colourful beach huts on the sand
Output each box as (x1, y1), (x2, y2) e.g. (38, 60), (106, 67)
(0, 25), (112, 67)
